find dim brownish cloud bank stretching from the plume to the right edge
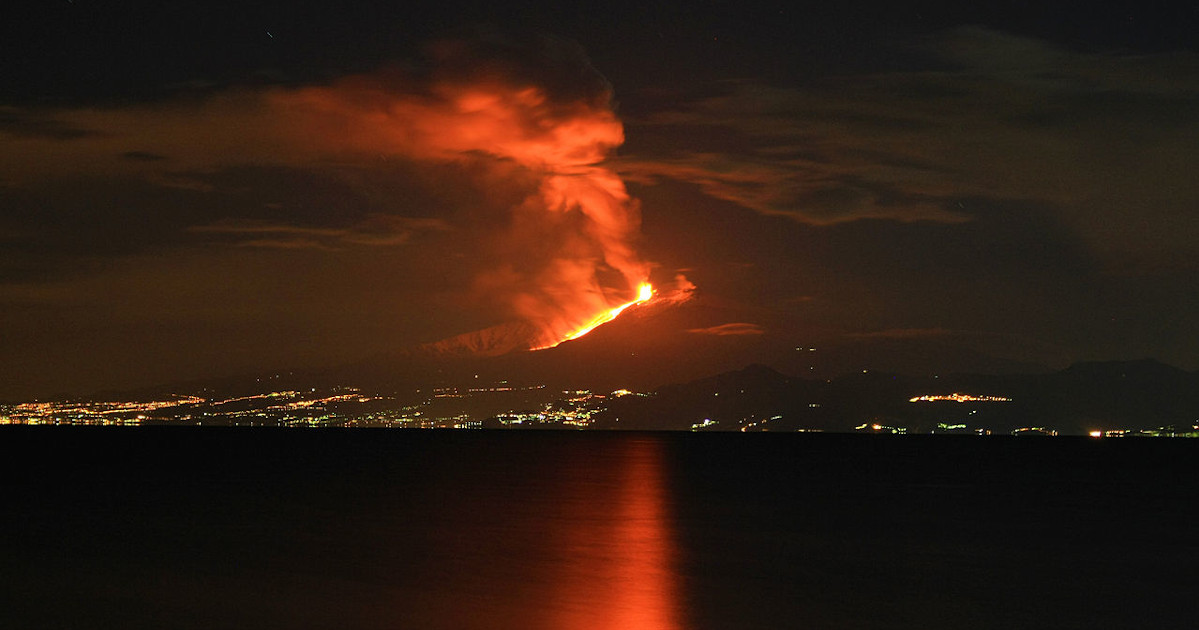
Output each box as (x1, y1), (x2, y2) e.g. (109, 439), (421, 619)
(621, 28), (1199, 265)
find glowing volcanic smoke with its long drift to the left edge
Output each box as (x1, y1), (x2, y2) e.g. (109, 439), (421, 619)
(0, 32), (650, 347)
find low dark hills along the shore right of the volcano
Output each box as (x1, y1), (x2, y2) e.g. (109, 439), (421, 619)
(589, 360), (1199, 434)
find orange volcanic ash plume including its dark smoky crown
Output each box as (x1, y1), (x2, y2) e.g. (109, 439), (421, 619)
(278, 35), (649, 354)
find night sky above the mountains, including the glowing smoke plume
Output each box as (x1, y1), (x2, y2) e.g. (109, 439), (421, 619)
(0, 0), (1199, 398)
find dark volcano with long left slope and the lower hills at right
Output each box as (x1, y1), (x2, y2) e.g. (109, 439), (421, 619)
(74, 289), (1199, 433)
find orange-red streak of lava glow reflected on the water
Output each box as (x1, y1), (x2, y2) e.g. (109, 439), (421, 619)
(547, 438), (681, 630)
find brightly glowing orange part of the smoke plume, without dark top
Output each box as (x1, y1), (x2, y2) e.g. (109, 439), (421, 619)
(272, 60), (649, 347)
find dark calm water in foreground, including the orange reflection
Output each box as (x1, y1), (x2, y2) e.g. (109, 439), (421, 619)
(0, 427), (1199, 630)
